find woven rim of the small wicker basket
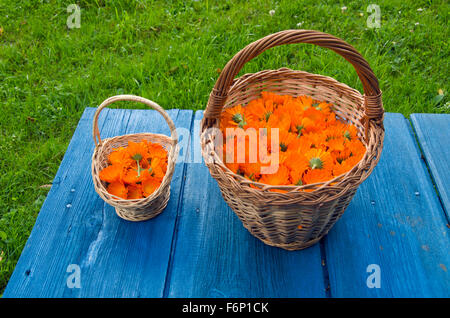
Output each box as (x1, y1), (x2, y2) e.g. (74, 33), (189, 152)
(91, 132), (178, 205)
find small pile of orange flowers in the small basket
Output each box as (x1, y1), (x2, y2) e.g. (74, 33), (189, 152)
(99, 140), (167, 200)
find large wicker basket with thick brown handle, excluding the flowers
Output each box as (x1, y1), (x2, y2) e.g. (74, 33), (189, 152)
(201, 30), (384, 250)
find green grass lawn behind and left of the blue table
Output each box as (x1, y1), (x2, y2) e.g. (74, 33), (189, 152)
(0, 0), (450, 293)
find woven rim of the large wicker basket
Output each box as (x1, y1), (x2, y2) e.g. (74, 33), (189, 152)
(201, 67), (384, 197)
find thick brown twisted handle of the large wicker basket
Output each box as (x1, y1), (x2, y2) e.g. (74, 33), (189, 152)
(203, 30), (384, 127)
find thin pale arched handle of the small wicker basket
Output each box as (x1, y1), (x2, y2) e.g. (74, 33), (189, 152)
(93, 95), (178, 148)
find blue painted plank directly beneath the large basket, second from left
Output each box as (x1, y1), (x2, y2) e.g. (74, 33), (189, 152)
(167, 111), (326, 298)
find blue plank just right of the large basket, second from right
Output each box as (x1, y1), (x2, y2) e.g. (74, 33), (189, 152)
(325, 114), (450, 297)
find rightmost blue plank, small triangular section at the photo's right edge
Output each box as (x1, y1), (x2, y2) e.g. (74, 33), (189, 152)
(411, 114), (450, 220)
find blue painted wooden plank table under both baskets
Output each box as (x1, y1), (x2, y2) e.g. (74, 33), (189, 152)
(4, 108), (450, 298)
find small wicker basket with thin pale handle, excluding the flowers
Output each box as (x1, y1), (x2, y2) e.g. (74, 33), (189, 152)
(92, 95), (178, 221)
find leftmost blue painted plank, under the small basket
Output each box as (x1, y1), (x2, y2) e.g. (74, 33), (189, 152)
(4, 108), (193, 297)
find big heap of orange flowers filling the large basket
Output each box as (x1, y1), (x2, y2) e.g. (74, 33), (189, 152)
(220, 92), (366, 185)
